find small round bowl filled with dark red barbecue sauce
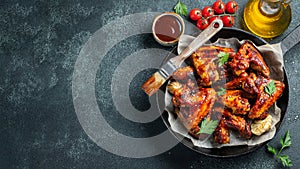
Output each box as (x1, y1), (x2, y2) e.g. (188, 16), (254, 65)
(152, 12), (185, 46)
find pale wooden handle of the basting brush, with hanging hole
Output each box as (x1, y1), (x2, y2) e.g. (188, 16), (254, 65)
(170, 19), (223, 67)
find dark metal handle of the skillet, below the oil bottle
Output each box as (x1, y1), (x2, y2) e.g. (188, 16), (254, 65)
(281, 25), (300, 55)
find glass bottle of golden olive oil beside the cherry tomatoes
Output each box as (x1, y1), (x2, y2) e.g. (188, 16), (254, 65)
(243, 0), (292, 38)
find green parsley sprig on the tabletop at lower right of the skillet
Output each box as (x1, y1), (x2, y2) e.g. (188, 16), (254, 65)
(267, 131), (293, 167)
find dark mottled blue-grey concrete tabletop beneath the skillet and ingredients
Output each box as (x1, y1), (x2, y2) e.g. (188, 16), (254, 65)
(0, 0), (300, 169)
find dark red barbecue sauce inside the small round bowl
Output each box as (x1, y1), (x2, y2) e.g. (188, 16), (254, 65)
(154, 15), (182, 42)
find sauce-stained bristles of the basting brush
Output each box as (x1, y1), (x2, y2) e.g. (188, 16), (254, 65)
(142, 72), (166, 96)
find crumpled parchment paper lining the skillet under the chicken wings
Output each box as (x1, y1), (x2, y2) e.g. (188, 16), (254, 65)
(165, 35), (284, 148)
